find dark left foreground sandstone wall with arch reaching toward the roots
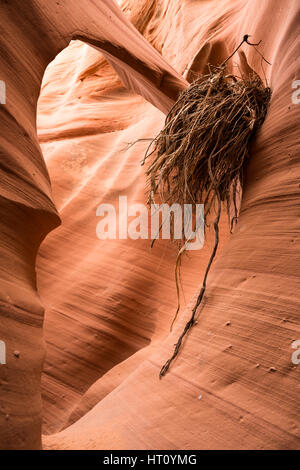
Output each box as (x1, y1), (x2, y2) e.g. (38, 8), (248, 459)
(0, 0), (189, 449)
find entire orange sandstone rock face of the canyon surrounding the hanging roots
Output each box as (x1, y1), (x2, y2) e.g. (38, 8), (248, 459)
(0, 0), (300, 449)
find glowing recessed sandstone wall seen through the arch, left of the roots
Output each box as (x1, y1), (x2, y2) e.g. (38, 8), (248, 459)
(37, 42), (216, 433)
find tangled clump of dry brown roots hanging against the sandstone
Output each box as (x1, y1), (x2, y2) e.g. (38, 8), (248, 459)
(144, 51), (271, 377)
